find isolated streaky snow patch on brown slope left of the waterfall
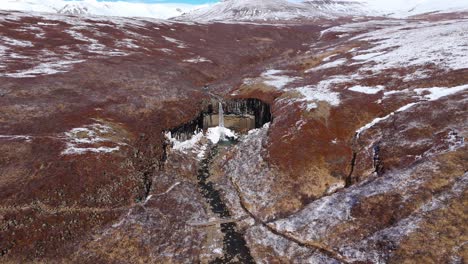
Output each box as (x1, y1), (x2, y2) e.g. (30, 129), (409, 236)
(62, 123), (121, 155)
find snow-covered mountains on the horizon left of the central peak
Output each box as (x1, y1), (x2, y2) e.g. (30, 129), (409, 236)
(0, 0), (203, 19)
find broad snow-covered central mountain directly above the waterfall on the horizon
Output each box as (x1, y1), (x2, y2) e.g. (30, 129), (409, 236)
(176, 0), (365, 21)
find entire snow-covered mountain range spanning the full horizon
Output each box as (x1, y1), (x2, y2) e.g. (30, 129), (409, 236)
(0, 0), (468, 21)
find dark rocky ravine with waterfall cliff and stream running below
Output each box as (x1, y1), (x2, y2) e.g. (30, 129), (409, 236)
(164, 98), (272, 263)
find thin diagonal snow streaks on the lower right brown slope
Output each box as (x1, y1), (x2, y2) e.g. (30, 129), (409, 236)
(272, 162), (468, 255)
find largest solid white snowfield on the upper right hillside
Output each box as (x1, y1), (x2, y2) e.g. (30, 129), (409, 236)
(353, 20), (468, 71)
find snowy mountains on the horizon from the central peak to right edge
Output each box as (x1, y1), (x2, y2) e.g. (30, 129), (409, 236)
(175, 0), (468, 21)
